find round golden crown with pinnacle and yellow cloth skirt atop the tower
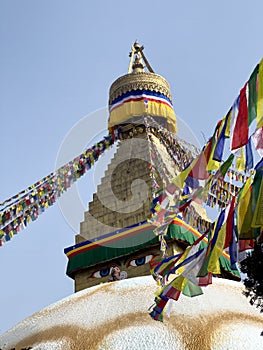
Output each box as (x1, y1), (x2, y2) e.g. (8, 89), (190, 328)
(108, 41), (177, 133)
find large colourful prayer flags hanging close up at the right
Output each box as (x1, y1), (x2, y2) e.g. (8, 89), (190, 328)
(148, 60), (263, 320)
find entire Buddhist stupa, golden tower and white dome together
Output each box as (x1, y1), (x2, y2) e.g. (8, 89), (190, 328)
(0, 41), (263, 350)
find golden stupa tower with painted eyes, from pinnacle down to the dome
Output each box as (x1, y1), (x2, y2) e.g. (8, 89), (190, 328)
(65, 41), (239, 292)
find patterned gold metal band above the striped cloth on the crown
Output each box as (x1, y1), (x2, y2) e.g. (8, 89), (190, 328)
(109, 72), (172, 105)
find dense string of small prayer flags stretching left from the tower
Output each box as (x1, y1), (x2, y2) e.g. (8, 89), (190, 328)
(0, 130), (119, 245)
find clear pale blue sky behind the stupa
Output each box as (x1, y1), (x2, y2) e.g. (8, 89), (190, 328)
(0, 0), (263, 334)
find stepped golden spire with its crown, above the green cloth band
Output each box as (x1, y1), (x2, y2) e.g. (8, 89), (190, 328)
(76, 42), (177, 238)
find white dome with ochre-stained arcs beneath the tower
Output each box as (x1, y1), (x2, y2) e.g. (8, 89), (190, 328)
(0, 276), (263, 350)
